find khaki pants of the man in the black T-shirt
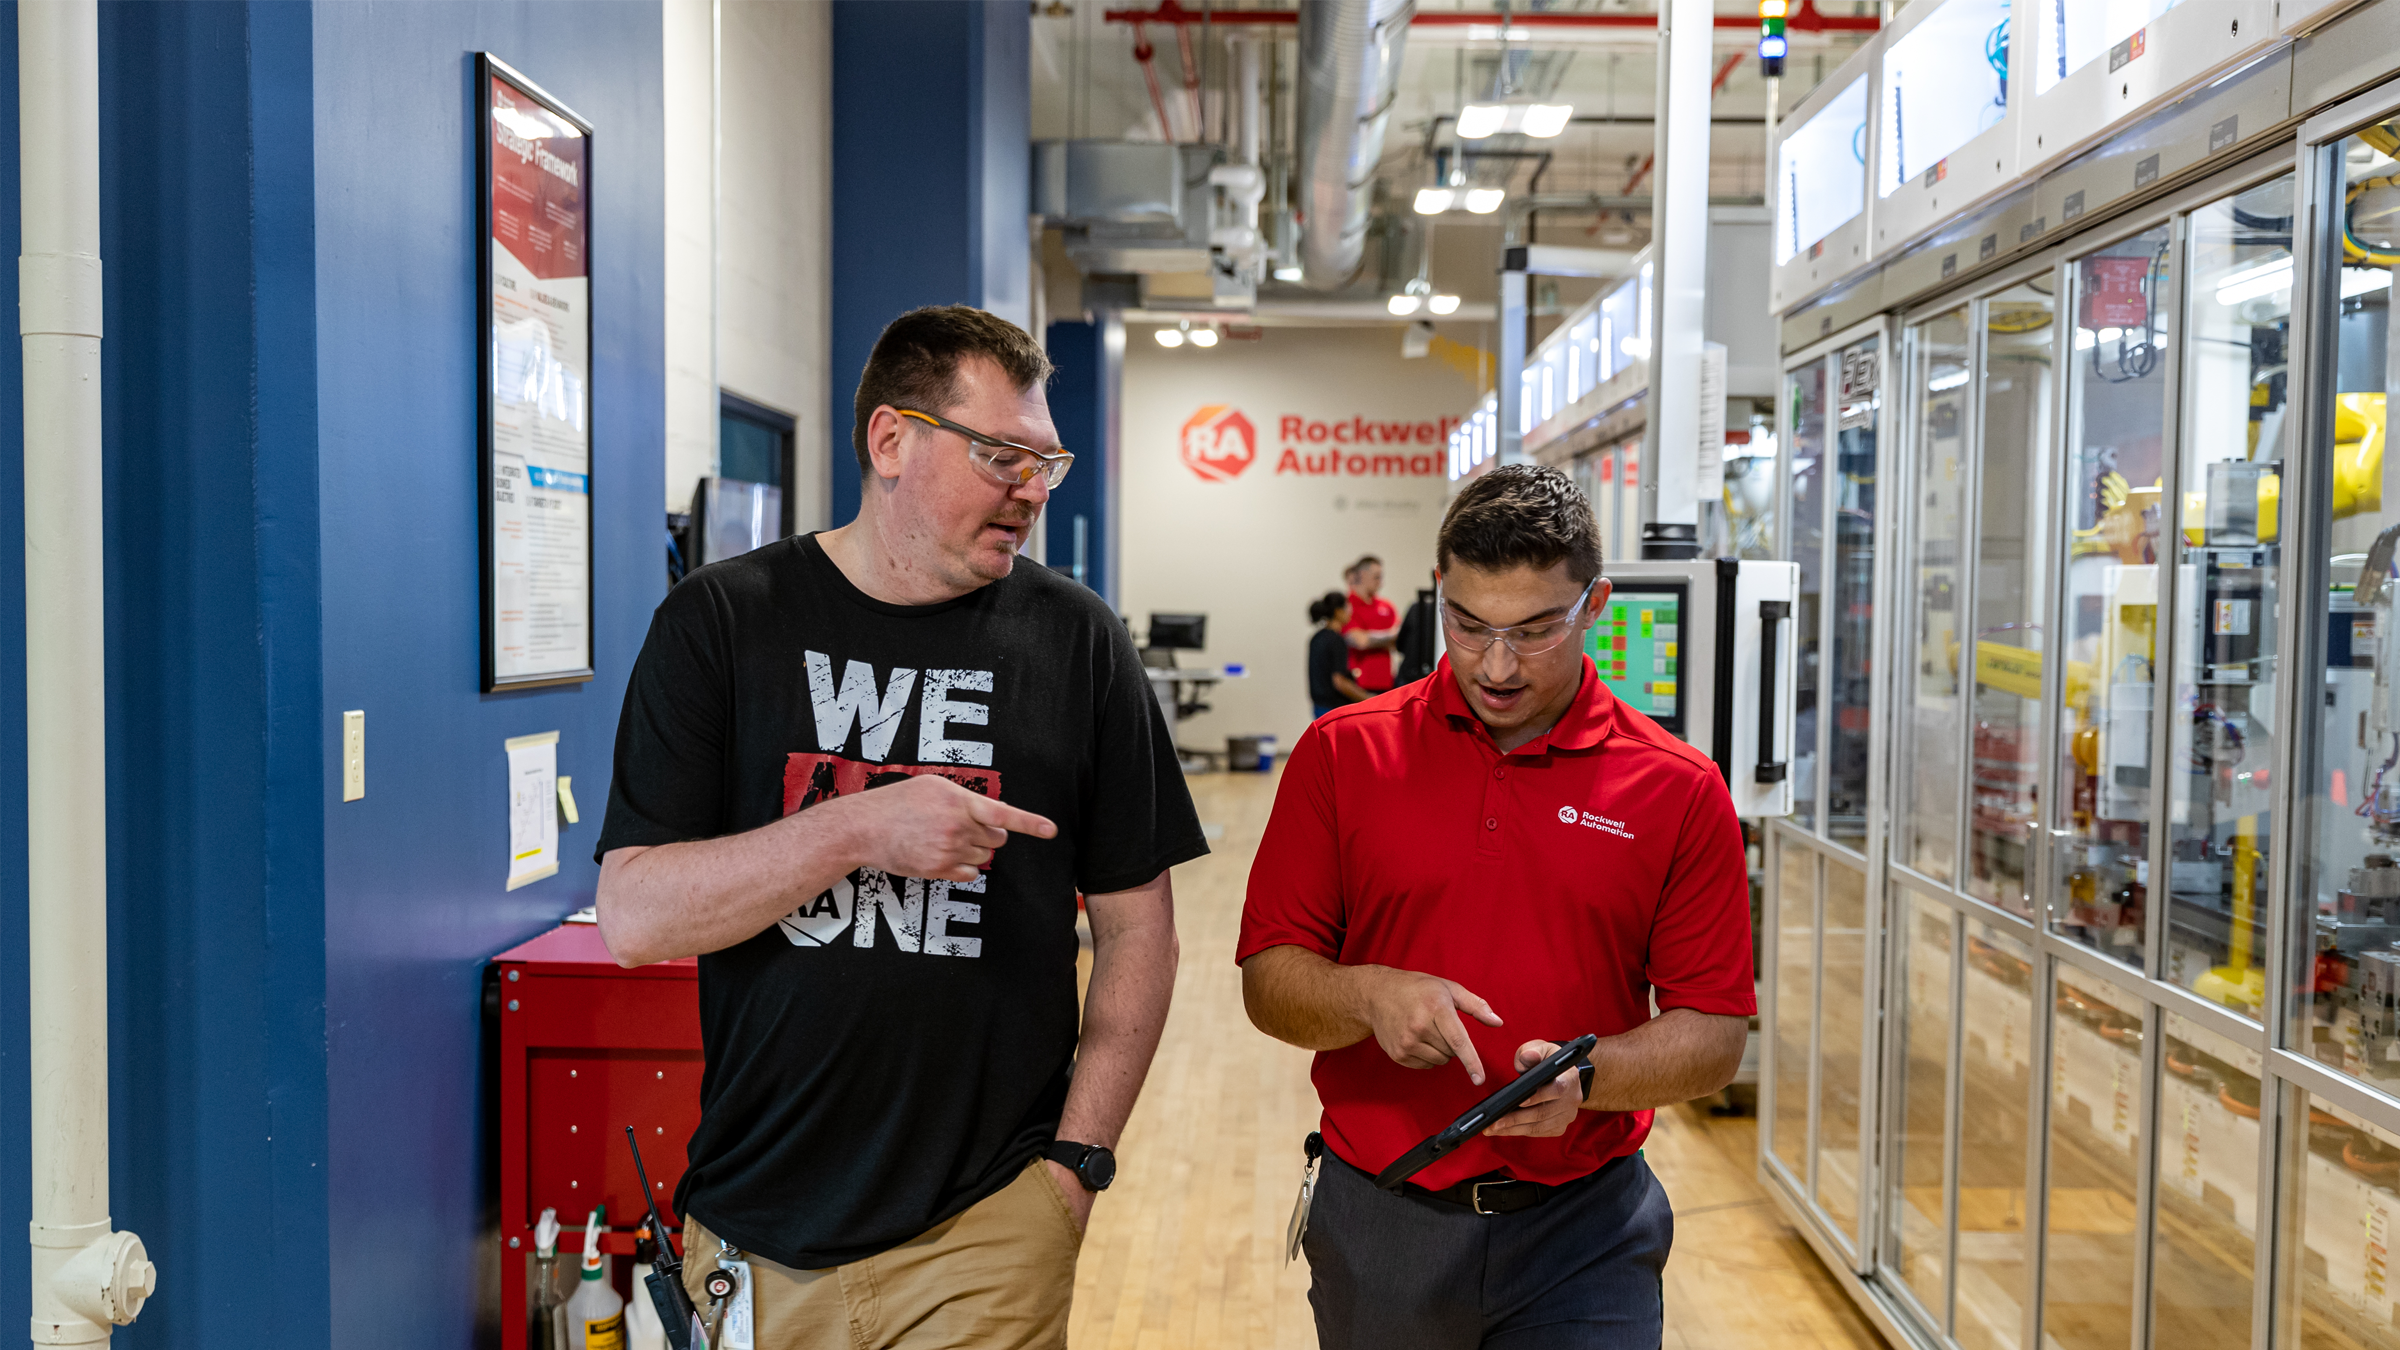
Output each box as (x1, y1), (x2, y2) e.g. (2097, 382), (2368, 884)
(684, 1158), (1082, 1350)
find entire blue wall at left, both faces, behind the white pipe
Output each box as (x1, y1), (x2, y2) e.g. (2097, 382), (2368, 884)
(72, 0), (665, 1350)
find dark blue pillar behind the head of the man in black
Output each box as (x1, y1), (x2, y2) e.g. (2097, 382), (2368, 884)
(826, 0), (1032, 524)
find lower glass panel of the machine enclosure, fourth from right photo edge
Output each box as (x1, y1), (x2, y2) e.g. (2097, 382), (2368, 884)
(1951, 920), (2038, 1350)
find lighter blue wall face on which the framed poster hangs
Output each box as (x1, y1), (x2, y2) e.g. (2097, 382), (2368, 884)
(312, 0), (665, 1345)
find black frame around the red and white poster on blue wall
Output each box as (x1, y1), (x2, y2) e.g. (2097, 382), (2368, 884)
(475, 50), (600, 694)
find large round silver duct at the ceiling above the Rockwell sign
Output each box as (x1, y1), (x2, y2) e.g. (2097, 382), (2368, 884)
(1298, 0), (1416, 291)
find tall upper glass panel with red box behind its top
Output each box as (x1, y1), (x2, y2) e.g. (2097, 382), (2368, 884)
(2050, 226), (2172, 966)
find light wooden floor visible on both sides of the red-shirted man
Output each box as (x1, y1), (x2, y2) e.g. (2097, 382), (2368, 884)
(1068, 773), (1882, 1350)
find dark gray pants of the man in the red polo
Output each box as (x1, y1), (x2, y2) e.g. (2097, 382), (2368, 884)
(1303, 1153), (1675, 1350)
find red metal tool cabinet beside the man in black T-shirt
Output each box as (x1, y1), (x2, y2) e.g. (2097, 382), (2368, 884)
(492, 922), (701, 1350)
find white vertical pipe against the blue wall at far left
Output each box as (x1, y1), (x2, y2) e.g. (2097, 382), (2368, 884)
(17, 0), (154, 1345)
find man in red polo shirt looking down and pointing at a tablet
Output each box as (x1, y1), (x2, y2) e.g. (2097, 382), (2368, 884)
(1236, 466), (1754, 1350)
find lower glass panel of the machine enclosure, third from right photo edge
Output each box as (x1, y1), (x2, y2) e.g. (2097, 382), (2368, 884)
(2042, 963), (2141, 1350)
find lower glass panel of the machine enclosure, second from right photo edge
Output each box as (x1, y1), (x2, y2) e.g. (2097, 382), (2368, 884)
(2150, 1011), (2258, 1350)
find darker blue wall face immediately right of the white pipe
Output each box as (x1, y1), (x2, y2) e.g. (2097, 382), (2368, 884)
(102, 0), (329, 1348)
